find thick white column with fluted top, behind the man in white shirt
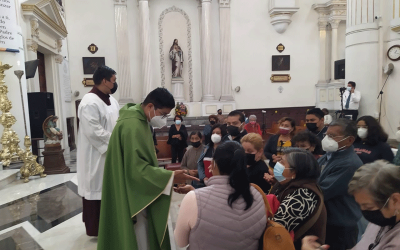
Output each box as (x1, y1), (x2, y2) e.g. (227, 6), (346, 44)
(345, 0), (382, 117)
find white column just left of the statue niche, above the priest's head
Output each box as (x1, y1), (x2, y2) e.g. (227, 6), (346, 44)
(139, 0), (155, 100)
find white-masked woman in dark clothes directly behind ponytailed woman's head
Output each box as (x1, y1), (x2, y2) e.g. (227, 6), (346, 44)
(197, 124), (227, 183)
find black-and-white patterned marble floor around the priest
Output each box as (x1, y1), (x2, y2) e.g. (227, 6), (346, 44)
(0, 172), (184, 250)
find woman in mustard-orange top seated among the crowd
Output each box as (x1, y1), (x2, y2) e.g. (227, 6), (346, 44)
(264, 117), (296, 168)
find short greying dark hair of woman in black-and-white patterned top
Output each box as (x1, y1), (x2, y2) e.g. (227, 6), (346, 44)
(283, 148), (321, 180)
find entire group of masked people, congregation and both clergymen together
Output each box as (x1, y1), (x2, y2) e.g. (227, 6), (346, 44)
(78, 66), (400, 250)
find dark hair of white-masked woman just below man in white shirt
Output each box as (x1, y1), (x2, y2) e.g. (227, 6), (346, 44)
(356, 115), (389, 146)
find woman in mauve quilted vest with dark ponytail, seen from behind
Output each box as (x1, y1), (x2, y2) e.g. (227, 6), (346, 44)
(175, 141), (267, 250)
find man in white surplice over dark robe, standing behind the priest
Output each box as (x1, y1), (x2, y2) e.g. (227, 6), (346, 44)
(77, 66), (119, 236)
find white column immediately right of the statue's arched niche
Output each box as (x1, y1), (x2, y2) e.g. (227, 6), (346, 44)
(201, 0), (215, 102)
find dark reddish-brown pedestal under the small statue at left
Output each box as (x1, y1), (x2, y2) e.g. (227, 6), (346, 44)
(42, 143), (70, 174)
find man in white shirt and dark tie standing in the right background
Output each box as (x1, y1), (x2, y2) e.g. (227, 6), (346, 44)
(343, 81), (361, 121)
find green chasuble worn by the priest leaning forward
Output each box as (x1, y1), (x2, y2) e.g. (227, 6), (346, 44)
(97, 104), (173, 250)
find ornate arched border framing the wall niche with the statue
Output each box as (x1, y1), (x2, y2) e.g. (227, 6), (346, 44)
(158, 6), (193, 102)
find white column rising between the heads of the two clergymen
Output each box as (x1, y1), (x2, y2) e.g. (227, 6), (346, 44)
(114, 0), (134, 106)
